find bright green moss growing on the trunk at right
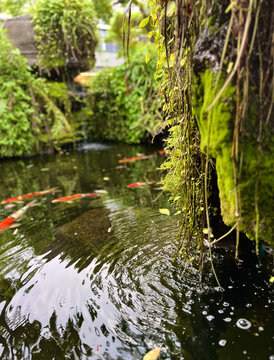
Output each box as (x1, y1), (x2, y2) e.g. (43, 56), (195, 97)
(193, 70), (274, 244)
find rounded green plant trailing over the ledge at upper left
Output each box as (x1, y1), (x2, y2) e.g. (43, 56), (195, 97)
(32, 0), (97, 69)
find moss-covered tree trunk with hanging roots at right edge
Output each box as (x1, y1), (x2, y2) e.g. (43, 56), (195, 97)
(193, 0), (274, 246)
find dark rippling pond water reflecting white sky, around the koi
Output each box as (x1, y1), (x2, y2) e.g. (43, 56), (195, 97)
(0, 144), (274, 360)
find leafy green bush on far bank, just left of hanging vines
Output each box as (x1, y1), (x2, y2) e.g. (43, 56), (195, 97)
(83, 47), (161, 143)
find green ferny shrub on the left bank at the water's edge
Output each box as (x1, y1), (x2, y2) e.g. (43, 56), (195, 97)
(0, 30), (79, 156)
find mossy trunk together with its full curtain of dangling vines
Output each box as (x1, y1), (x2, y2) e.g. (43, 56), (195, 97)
(125, 0), (274, 280)
